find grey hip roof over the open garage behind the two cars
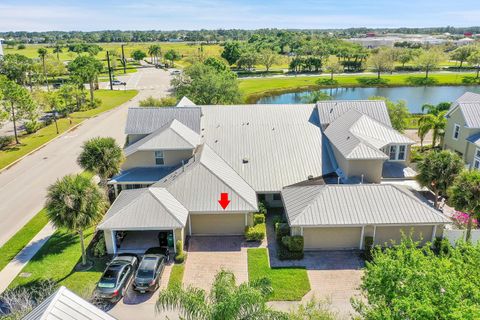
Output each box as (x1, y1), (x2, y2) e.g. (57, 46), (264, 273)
(98, 187), (188, 230)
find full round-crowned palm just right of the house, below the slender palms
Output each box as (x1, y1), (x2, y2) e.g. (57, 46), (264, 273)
(417, 150), (464, 208)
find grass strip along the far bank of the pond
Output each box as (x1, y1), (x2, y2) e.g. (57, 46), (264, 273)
(239, 72), (474, 102)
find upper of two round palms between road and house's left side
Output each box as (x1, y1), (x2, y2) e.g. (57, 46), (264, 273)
(77, 137), (124, 187)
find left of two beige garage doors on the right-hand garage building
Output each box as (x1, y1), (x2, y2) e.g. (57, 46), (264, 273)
(303, 227), (362, 250)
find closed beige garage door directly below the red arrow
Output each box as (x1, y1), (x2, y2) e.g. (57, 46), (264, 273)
(190, 213), (245, 235)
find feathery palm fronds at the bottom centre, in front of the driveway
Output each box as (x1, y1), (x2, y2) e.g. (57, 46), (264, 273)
(155, 270), (287, 320)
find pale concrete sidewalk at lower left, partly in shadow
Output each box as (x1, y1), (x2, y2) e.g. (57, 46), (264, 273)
(0, 223), (55, 294)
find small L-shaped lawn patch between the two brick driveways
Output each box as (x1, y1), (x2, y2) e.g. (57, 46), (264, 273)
(248, 248), (310, 301)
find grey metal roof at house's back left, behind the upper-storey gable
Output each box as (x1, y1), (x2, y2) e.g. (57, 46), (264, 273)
(125, 107), (201, 134)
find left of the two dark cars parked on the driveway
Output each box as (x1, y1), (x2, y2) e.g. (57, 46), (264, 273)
(95, 253), (138, 303)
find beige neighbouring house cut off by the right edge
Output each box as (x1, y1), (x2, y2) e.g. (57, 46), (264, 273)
(444, 92), (480, 169)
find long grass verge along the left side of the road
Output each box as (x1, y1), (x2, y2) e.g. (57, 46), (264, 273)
(0, 90), (138, 169)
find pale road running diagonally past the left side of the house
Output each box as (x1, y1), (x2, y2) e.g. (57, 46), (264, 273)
(0, 68), (170, 246)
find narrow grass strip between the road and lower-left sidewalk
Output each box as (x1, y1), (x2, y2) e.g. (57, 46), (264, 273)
(0, 209), (48, 271)
